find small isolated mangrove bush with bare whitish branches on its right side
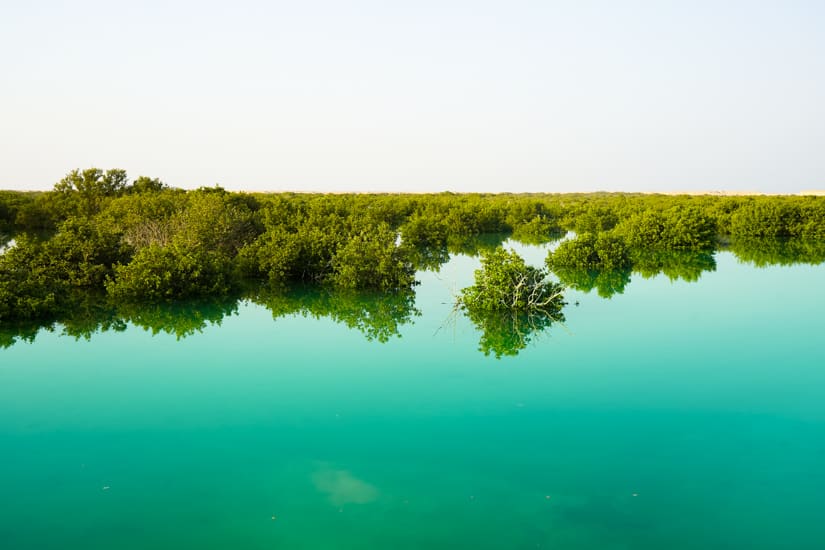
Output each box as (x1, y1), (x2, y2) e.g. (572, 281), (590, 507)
(458, 247), (564, 313)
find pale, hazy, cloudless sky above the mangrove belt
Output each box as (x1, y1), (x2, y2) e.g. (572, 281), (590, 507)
(0, 0), (825, 193)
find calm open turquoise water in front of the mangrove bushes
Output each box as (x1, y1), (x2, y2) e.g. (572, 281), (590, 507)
(0, 248), (825, 549)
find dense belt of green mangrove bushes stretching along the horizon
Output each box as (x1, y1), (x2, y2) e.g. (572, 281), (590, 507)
(0, 169), (825, 354)
